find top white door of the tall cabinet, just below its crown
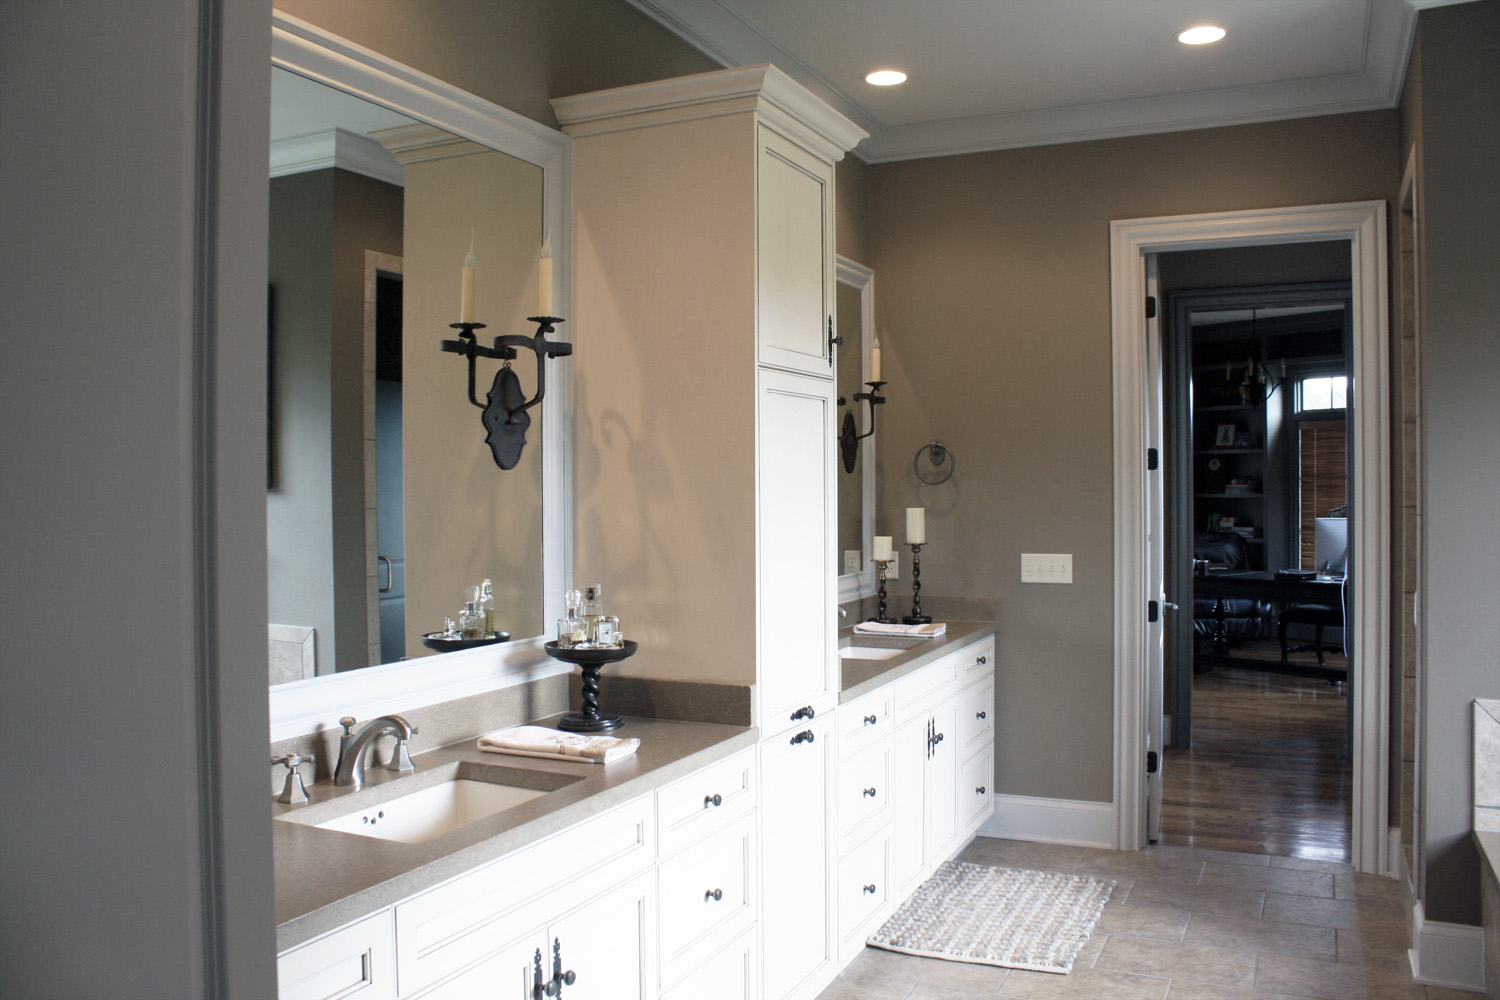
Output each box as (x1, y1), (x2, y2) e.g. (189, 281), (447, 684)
(756, 127), (833, 378)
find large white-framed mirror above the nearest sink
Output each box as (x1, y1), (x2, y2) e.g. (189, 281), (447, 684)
(267, 12), (573, 741)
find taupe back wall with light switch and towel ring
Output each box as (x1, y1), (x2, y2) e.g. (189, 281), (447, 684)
(867, 111), (1400, 802)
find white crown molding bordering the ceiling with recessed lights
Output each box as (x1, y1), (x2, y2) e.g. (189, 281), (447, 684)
(627, 0), (1416, 163)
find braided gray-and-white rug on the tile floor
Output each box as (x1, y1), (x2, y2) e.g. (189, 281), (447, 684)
(866, 861), (1115, 973)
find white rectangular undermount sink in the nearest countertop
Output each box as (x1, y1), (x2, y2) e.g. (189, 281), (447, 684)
(282, 763), (578, 844)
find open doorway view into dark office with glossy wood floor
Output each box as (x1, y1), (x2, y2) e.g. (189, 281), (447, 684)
(1158, 241), (1358, 861)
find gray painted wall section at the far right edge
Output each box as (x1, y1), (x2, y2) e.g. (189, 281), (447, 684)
(1407, 0), (1500, 924)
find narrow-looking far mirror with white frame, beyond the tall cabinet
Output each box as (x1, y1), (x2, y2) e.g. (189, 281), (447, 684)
(836, 256), (879, 604)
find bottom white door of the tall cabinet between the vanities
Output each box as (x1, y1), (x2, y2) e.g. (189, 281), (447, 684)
(761, 717), (834, 1000)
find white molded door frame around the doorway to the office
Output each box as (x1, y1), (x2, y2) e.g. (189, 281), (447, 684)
(1110, 201), (1391, 874)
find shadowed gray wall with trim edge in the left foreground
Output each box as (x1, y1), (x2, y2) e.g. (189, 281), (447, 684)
(0, 0), (275, 997)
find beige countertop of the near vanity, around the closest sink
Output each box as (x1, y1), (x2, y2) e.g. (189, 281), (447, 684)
(272, 717), (758, 952)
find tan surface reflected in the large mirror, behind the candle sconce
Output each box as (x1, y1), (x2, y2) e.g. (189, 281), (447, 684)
(402, 151), (549, 658)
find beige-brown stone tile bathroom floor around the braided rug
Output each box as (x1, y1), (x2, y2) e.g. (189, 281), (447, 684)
(819, 837), (1476, 1000)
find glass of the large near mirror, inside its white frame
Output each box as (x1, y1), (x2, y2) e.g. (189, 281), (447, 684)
(267, 69), (543, 684)
